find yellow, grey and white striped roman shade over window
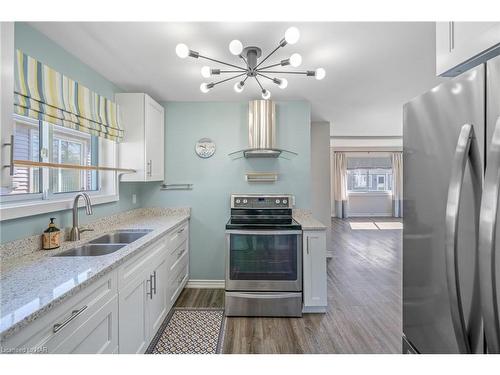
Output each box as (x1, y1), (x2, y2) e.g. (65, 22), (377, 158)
(14, 50), (123, 141)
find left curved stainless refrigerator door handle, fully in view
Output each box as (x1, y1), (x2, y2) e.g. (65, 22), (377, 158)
(445, 124), (483, 353)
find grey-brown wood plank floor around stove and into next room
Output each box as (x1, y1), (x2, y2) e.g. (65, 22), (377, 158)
(176, 218), (402, 354)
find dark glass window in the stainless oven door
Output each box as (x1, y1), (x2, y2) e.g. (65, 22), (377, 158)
(229, 234), (299, 280)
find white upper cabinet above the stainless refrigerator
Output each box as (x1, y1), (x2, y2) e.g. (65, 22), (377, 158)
(436, 22), (500, 77)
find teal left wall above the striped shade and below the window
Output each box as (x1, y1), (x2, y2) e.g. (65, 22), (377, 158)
(0, 22), (142, 243)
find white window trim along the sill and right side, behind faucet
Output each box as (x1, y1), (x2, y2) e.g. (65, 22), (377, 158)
(0, 131), (120, 221)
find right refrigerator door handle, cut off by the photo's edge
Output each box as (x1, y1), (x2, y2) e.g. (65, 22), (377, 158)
(479, 117), (500, 353)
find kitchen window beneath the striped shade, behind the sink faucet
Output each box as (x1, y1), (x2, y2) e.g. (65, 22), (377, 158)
(0, 115), (117, 219)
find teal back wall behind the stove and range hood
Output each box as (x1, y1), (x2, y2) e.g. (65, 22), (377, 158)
(141, 101), (311, 280)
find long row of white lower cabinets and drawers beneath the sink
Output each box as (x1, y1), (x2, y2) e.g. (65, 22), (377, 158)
(1, 222), (189, 353)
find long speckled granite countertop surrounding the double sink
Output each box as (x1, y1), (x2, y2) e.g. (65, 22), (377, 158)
(0, 208), (190, 340)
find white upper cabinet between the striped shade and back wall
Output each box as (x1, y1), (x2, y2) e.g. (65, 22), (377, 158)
(115, 93), (165, 181)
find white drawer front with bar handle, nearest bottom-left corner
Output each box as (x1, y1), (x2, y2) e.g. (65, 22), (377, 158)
(2, 272), (117, 353)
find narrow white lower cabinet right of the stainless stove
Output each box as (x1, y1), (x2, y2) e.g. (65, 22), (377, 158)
(302, 230), (327, 313)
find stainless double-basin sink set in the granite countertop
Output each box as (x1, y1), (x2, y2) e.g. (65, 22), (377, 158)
(54, 229), (153, 257)
